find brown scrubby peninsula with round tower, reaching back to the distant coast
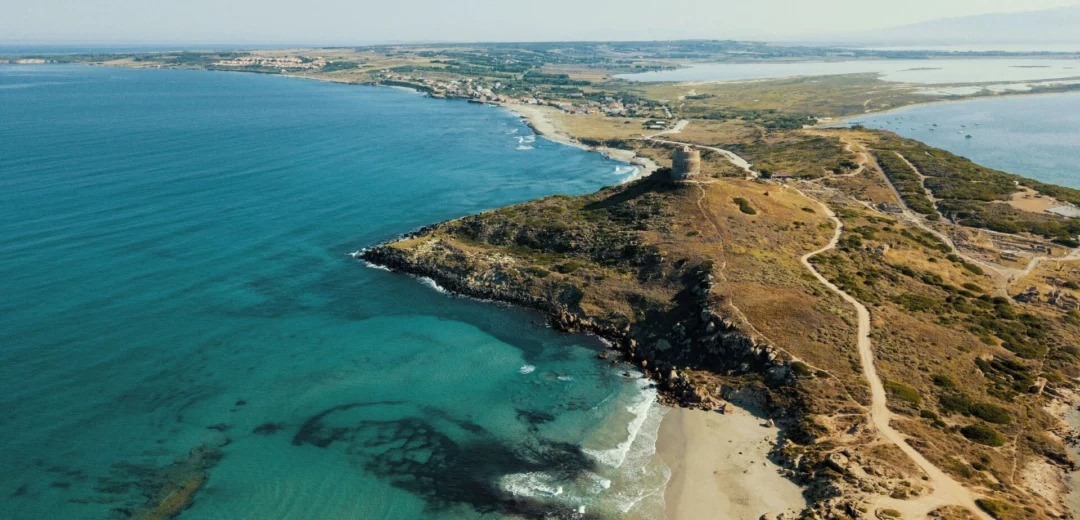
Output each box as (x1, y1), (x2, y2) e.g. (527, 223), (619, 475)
(14, 41), (1080, 519)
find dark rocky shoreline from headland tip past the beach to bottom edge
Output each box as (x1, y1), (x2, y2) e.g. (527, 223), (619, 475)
(361, 229), (898, 518)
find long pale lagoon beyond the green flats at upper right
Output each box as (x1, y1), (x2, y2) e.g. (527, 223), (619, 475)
(617, 58), (1080, 84)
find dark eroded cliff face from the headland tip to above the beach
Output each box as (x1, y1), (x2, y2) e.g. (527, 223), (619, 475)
(364, 237), (798, 408)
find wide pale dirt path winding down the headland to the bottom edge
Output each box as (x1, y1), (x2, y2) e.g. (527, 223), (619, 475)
(800, 193), (993, 520)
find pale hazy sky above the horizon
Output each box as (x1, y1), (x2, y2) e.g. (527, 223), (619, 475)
(6, 0), (1080, 44)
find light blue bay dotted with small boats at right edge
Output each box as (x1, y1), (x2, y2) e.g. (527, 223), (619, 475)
(850, 93), (1080, 188)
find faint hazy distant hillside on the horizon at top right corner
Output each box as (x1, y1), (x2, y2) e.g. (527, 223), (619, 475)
(815, 6), (1080, 45)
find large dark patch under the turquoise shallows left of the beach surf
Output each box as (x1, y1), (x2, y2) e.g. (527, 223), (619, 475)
(293, 403), (595, 519)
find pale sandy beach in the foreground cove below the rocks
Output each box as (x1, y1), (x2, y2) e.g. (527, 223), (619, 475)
(657, 405), (806, 520)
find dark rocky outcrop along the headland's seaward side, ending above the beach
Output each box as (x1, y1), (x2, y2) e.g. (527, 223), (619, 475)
(362, 241), (794, 410)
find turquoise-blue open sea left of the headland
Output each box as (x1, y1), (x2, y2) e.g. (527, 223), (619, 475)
(0, 66), (667, 520)
